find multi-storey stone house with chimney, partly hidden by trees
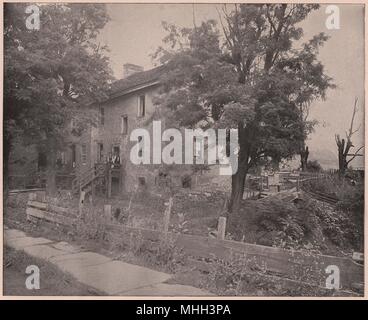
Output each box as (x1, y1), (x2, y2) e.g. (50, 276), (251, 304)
(7, 64), (204, 195)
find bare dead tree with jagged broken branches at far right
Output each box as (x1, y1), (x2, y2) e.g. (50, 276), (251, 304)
(335, 98), (364, 176)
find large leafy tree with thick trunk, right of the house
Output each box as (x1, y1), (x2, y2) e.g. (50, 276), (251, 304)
(152, 4), (332, 211)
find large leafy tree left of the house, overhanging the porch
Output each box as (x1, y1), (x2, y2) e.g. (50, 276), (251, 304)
(4, 3), (111, 194)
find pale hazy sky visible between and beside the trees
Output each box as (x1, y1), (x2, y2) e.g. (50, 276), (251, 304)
(100, 4), (364, 166)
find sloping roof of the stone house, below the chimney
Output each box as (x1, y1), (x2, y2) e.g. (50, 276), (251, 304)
(110, 65), (165, 98)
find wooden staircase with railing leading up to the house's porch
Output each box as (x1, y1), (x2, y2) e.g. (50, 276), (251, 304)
(72, 164), (107, 194)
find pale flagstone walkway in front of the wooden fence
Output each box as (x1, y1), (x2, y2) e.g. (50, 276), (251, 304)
(4, 227), (212, 296)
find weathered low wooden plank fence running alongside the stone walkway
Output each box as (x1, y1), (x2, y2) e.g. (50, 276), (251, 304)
(26, 198), (364, 290)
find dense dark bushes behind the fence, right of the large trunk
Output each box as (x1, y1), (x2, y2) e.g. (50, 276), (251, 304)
(227, 189), (364, 254)
